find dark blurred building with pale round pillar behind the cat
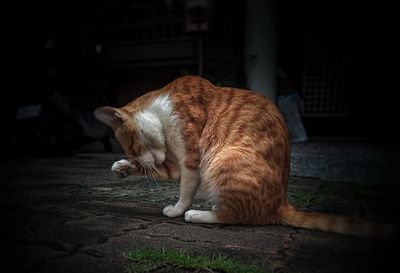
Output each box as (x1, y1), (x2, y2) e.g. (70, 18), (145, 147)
(6, 0), (395, 155)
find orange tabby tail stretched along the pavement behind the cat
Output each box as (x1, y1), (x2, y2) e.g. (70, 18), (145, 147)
(280, 204), (396, 239)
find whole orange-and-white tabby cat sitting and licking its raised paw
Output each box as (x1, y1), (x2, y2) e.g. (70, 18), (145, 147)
(95, 76), (394, 236)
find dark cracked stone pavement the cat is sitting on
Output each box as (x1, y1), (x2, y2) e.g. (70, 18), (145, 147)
(0, 153), (398, 273)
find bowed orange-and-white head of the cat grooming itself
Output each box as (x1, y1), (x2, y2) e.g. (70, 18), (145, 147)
(94, 106), (166, 167)
